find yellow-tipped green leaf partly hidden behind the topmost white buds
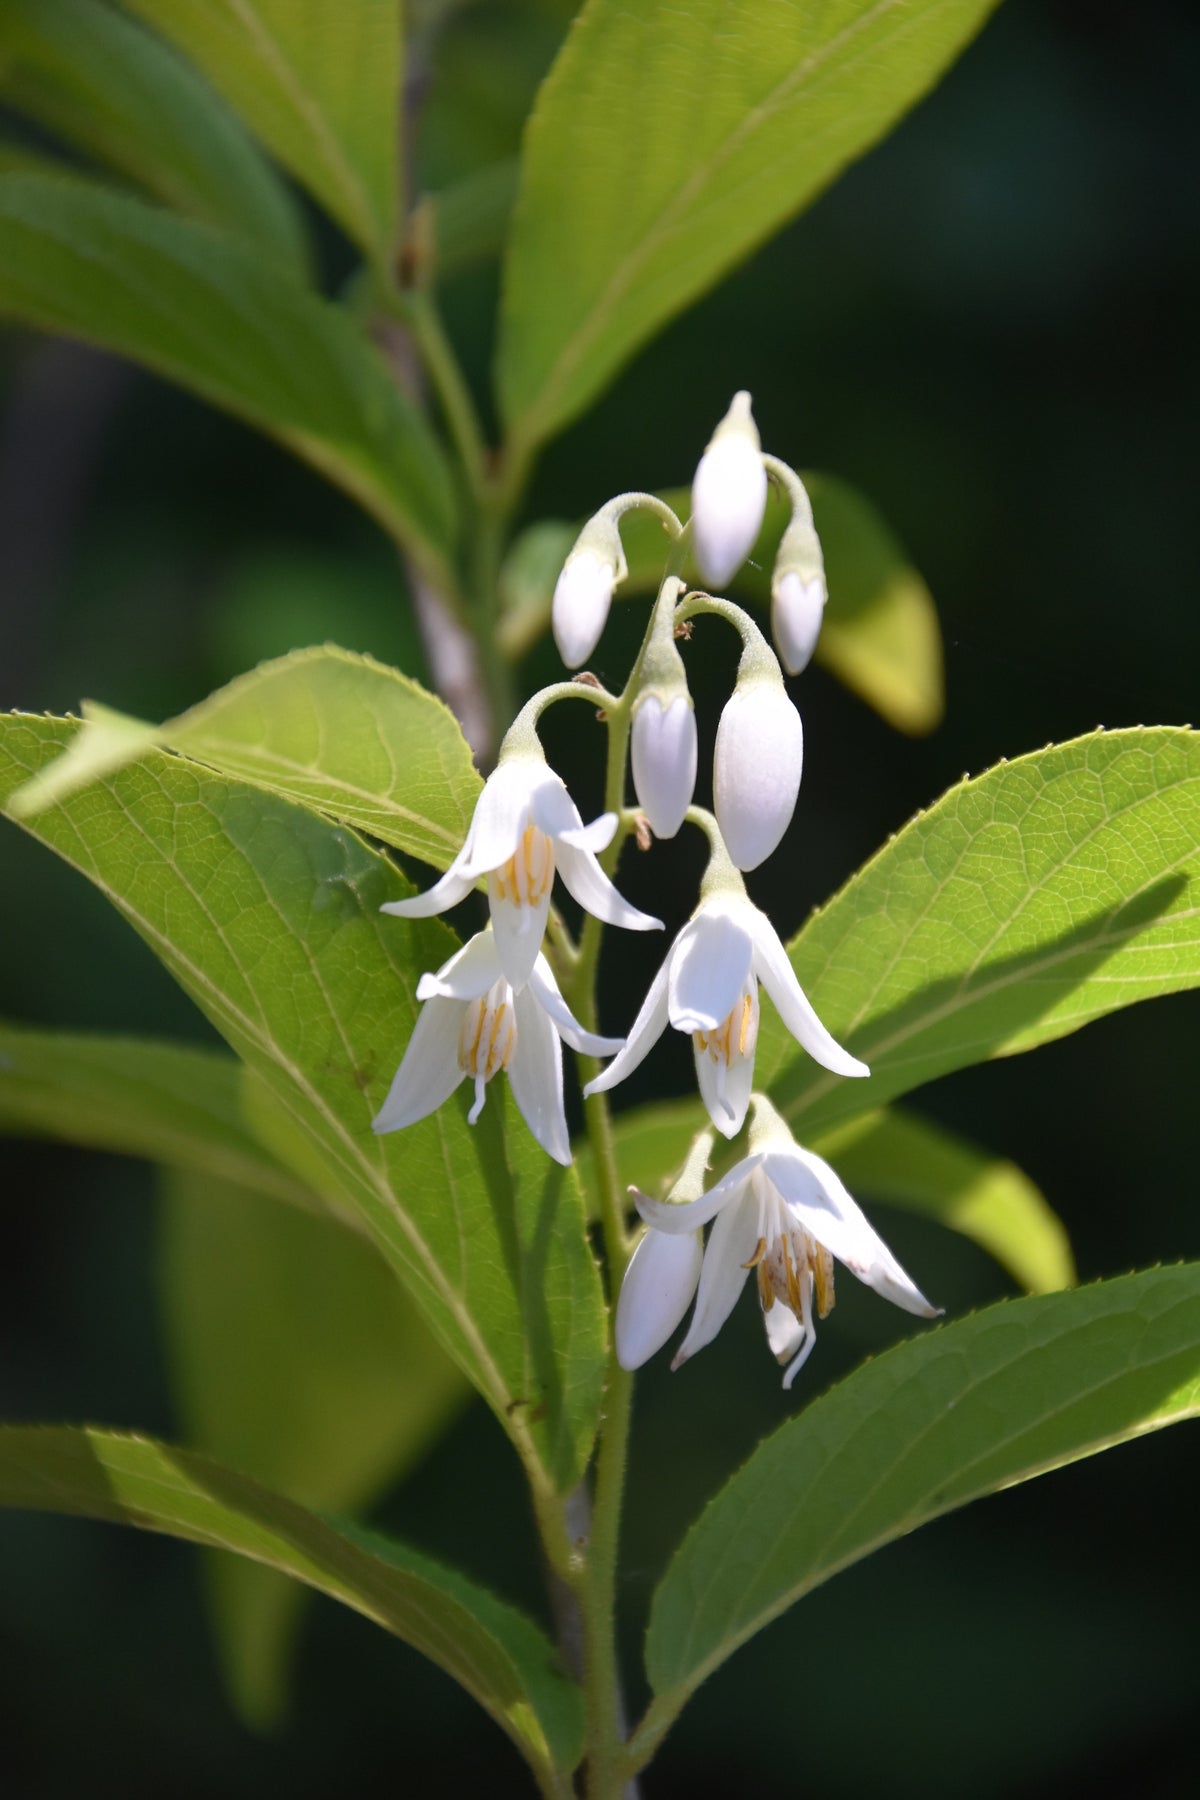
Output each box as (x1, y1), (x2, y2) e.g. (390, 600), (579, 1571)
(500, 473), (945, 734)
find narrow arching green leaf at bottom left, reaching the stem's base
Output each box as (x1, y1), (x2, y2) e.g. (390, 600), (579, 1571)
(0, 1426), (583, 1771)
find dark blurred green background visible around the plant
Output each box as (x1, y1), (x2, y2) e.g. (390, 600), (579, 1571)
(0, 0), (1200, 1800)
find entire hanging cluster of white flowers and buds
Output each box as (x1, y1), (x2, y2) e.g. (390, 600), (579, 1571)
(374, 394), (936, 1386)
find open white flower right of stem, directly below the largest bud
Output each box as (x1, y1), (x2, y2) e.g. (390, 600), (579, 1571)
(583, 891), (871, 1138)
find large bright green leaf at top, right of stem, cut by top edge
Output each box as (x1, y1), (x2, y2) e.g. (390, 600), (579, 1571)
(497, 0), (993, 457)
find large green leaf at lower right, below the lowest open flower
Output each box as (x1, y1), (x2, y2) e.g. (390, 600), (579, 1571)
(639, 1265), (1200, 1755)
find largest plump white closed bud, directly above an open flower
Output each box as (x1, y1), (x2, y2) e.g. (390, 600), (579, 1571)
(712, 677), (804, 869)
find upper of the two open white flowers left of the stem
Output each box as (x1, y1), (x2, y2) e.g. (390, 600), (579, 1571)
(380, 754), (662, 988)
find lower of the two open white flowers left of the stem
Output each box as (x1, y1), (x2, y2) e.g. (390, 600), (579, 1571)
(372, 927), (621, 1163)
